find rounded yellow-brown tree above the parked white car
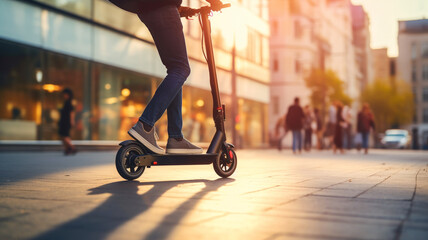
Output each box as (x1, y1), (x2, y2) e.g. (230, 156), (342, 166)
(361, 79), (414, 132)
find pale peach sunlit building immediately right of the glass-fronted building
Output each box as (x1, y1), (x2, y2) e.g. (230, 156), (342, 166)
(269, 0), (318, 129)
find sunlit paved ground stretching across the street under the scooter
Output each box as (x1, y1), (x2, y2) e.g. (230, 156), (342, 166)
(0, 149), (428, 240)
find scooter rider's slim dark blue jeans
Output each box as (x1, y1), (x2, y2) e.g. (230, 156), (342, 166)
(138, 5), (190, 138)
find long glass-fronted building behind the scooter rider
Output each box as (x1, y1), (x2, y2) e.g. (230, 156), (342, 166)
(0, 0), (270, 147)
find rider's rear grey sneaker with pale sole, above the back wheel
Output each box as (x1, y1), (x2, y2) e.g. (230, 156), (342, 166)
(128, 121), (165, 154)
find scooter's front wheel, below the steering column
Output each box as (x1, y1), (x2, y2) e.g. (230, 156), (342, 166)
(213, 149), (238, 178)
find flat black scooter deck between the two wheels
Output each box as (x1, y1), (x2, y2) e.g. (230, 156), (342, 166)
(135, 153), (218, 167)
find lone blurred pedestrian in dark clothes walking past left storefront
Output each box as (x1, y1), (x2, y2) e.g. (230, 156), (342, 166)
(58, 88), (77, 155)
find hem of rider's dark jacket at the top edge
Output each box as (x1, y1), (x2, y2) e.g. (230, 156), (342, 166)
(109, 0), (182, 14)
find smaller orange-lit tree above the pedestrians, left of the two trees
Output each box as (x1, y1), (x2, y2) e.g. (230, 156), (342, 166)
(305, 69), (352, 116)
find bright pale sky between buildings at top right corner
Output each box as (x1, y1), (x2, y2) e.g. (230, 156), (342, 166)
(351, 0), (428, 57)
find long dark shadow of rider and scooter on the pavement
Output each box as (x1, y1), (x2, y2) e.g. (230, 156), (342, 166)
(34, 178), (234, 239)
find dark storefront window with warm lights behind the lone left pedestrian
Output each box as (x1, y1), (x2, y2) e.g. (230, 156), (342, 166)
(0, 41), (88, 140)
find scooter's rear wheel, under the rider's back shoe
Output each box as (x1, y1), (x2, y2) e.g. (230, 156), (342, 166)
(116, 143), (145, 180)
